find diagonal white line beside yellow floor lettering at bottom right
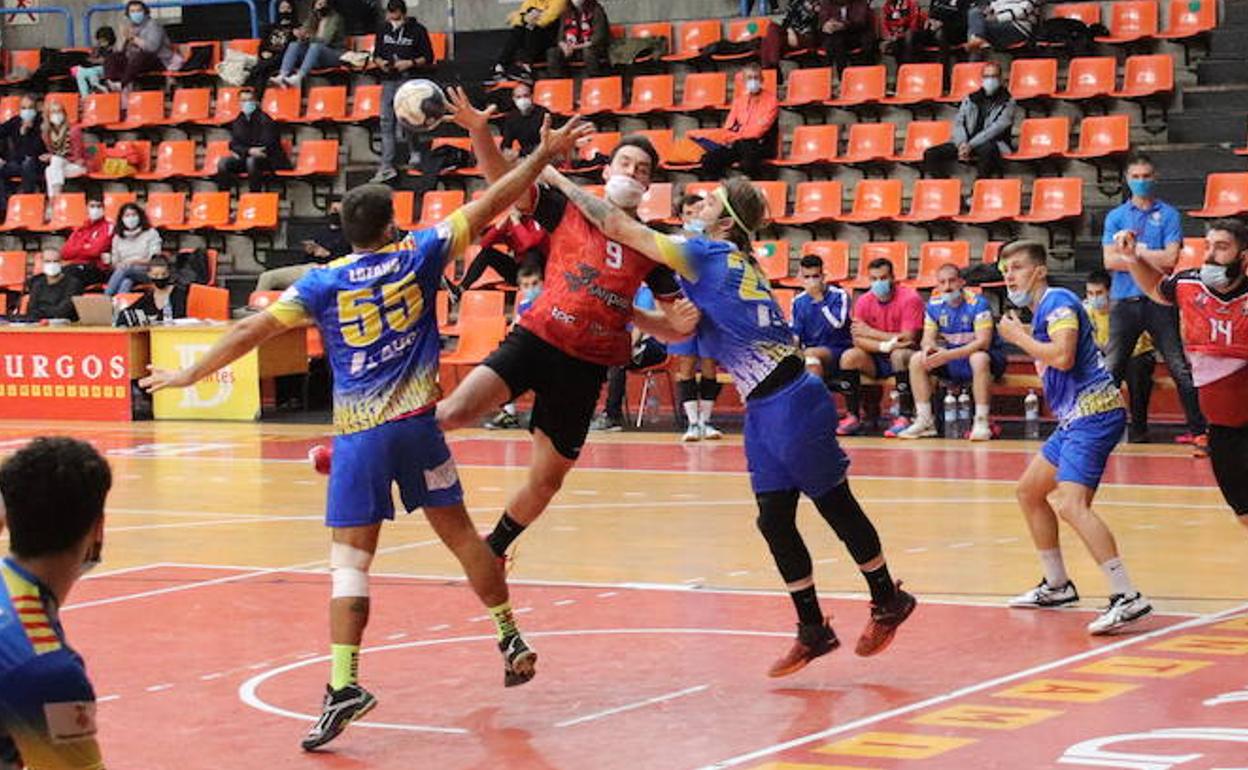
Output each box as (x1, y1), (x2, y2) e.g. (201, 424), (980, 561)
(698, 604), (1248, 770)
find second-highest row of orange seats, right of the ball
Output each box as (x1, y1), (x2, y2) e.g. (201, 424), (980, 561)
(533, 54), (1174, 117)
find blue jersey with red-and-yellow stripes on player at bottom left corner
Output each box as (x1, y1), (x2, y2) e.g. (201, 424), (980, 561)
(0, 559), (104, 770)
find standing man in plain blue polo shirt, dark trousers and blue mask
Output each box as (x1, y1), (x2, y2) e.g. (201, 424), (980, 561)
(1101, 155), (1206, 446)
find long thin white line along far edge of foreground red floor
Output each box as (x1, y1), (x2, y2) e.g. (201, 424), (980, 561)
(148, 562), (1202, 618)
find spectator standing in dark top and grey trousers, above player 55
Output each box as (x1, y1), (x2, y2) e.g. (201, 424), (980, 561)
(369, 0), (433, 183)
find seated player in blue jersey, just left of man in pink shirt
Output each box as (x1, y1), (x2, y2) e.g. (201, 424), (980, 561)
(791, 255), (854, 381)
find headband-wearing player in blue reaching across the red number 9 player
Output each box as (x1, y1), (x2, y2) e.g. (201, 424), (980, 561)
(544, 170), (915, 676)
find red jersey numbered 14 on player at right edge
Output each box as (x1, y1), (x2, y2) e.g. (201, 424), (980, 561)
(1157, 270), (1248, 427)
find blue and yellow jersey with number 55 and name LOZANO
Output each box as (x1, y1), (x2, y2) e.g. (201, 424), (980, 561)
(268, 211), (469, 433)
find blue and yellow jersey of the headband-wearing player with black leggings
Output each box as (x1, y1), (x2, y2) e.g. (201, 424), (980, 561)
(655, 233), (799, 401)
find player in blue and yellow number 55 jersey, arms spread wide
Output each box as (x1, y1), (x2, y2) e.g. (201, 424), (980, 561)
(140, 111), (590, 750)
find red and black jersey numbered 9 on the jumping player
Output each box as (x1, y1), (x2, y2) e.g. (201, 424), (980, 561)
(518, 187), (680, 366)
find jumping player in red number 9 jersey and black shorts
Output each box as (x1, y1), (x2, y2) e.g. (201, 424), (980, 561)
(438, 89), (698, 557)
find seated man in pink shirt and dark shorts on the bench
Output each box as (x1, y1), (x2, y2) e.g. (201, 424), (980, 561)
(836, 257), (925, 438)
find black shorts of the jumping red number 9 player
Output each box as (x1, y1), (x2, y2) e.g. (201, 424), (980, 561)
(483, 326), (607, 459)
